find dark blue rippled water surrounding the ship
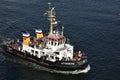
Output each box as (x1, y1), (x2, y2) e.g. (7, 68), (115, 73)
(0, 0), (120, 80)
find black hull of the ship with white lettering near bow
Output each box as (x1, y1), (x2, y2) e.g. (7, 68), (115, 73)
(3, 45), (90, 74)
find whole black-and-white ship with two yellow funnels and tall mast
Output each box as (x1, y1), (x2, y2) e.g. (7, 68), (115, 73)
(3, 3), (90, 74)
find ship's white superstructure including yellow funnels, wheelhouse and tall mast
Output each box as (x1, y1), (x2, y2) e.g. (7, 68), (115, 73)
(22, 3), (73, 62)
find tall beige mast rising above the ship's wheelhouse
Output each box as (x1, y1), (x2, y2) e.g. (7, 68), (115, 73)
(45, 3), (57, 35)
